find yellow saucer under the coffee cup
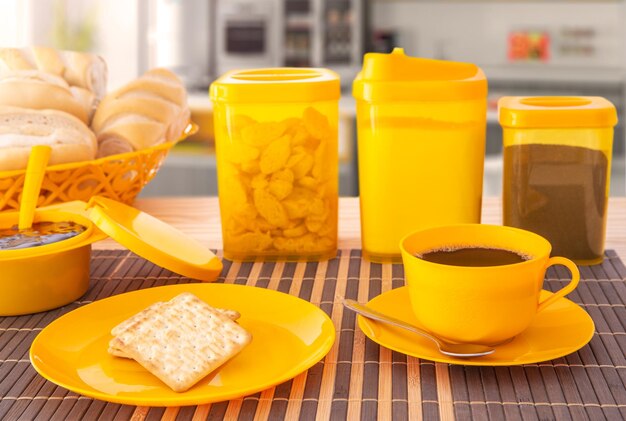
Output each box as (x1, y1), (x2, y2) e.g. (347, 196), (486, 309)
(358, 287), (595, 366)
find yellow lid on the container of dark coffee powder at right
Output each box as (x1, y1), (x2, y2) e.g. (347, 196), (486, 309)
(498, 96), (617, 129)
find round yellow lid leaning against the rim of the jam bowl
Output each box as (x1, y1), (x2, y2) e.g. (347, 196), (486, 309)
(87, 196), (222, 281)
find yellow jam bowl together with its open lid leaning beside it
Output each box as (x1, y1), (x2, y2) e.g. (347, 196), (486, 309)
(0, 196), (222, 316)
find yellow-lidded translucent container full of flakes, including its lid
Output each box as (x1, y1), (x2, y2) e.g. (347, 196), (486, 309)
(210, 68), (340, 260)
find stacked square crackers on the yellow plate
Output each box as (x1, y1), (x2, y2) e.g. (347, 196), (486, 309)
(109, 292), (252, 392)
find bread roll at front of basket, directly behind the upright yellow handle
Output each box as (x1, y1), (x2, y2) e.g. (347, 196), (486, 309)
(0, 106), (97, 171)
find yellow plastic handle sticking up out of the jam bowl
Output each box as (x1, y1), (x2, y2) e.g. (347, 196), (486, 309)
(18, 145), (52, 230)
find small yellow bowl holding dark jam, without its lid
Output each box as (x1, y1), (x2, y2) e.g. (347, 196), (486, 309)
(0, 203), (106, 316)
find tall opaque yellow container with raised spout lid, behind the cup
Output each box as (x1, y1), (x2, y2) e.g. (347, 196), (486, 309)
(353, 48), (487, 261)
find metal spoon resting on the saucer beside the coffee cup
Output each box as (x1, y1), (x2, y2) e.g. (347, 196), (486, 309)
(343, 298), (495, 358)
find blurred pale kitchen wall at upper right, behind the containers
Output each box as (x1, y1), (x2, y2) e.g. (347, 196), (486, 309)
(371, 0), (626, 68)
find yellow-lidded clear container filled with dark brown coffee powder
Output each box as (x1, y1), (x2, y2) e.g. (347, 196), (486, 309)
(498, 97), (617, 265)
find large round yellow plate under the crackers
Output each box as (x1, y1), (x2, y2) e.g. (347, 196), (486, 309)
(30, 284), (335, 406)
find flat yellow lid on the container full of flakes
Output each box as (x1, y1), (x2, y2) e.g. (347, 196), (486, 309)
(209, 67), (341, 103)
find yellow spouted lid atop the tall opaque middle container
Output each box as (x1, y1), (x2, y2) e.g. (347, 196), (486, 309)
(352, 48), (487, 101)
